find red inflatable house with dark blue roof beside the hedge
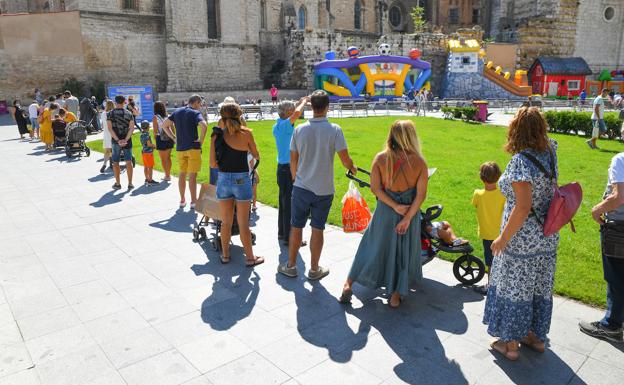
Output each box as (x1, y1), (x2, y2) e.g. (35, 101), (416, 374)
(529, 56), (592, 97)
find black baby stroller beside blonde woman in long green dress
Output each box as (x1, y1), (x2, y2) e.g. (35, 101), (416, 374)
(347, 167), (485, 285)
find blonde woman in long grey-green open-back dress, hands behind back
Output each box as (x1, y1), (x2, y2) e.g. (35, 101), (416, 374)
(340, 120), (428, 308)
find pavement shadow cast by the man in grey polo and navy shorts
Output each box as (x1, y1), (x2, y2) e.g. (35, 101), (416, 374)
(275, 247), (371, 362)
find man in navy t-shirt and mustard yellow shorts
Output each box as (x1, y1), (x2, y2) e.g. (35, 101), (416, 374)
(163, 95), (208, 209)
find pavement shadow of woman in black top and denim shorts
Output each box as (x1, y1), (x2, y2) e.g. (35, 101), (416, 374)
(191, 242), (260, 330)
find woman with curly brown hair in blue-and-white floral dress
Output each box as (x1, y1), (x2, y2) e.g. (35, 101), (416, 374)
(483, 107), (559, 361)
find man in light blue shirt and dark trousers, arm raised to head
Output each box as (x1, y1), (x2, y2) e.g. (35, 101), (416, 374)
(273, 97), (309, 244)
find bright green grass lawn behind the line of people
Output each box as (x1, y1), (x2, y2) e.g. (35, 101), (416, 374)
(90, 117), (621, 306)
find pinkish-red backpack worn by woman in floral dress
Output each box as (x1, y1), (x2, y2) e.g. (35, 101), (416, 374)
(521, 146), (583, 236)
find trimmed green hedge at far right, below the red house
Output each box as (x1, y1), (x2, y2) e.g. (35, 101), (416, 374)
(544, 111), (622, 139)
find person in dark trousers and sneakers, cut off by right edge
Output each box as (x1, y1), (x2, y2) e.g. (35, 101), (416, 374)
(579, 152), (624, 342)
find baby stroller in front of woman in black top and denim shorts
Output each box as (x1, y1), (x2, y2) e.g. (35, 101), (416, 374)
(193, 160), (260, 252)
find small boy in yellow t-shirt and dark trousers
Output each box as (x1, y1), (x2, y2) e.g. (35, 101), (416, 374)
(472, 162), (505, 295)
